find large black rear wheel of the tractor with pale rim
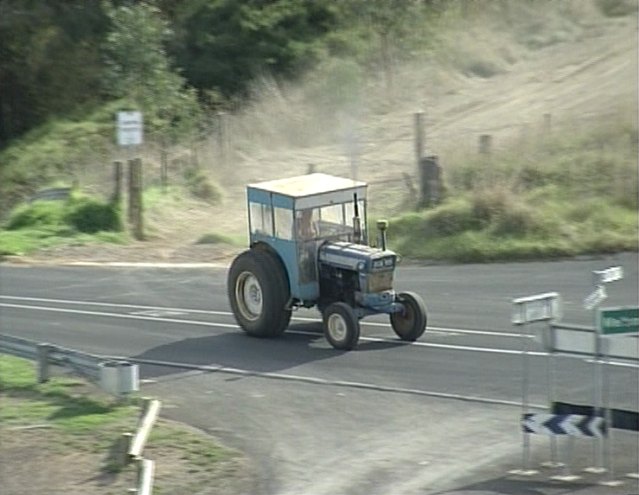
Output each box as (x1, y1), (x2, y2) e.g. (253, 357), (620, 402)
(227, 249), (291, 337)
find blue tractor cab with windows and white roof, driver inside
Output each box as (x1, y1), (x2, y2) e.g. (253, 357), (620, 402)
(247, 173), (368, 305)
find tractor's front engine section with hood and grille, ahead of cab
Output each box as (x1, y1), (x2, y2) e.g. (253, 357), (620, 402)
(318, 242), (397, 311)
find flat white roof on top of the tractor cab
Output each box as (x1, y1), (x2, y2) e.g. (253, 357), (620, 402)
(248, 173), (366, 198)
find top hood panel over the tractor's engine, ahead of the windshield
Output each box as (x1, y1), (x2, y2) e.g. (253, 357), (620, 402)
(319, 242), (397, 273)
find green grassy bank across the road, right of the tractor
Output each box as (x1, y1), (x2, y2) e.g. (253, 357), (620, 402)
(391, 117), (639, 262)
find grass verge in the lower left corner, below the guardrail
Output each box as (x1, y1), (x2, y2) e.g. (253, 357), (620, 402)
(0, 356), (246, 495)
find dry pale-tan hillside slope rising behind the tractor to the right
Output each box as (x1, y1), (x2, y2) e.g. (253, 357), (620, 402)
(17, 2), (638, 261)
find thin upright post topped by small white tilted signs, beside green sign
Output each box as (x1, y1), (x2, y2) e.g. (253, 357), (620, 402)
(584, 266), (623, 473)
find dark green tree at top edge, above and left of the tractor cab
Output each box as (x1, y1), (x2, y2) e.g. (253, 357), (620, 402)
(174, 0), (337, 97)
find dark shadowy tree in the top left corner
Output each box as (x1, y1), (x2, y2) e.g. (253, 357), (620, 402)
(0, 0), (106, 148)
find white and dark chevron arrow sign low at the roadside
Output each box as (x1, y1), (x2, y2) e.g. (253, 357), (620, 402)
(521, 413), (607, 437)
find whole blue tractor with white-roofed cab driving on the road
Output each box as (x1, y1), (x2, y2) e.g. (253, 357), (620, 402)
(227, 173), (426, 350)
